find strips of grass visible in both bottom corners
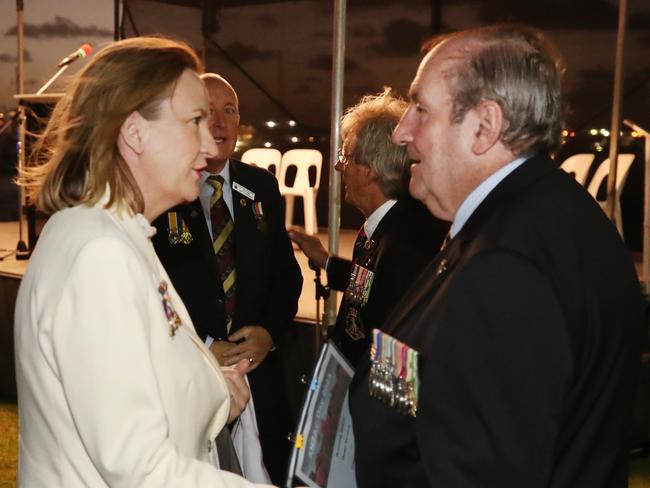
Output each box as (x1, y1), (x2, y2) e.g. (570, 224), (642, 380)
(0, 403), (650, 488)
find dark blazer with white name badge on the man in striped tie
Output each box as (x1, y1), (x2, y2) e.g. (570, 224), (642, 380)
(153, 159), (302, 482)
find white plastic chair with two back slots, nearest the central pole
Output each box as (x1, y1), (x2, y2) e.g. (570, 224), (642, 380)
(278, 149), (323, 235)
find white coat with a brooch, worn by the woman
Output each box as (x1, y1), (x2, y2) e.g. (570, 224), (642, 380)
(15, 199), (274, 488)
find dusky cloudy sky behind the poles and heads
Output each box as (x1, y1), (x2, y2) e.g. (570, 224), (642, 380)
(0, 0), (650, 133)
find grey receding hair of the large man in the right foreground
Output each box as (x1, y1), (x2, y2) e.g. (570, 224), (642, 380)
(426, 25), (564, 156)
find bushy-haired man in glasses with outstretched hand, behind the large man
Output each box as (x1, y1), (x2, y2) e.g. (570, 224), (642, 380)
(289, 89), (449, 366)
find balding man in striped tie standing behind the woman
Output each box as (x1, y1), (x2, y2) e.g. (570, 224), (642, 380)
(153, 74), (302, 483)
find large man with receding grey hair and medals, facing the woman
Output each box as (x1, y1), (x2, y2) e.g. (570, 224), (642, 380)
(350, 26), (642, 488)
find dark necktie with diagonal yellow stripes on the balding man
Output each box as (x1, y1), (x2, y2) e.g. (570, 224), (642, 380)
(207, 176), (236, 333)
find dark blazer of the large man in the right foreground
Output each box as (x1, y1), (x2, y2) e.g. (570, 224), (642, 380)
(350, 153), (642, 488)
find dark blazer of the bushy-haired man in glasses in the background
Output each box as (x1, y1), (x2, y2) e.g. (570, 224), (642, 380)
(327, 197), (449, 365)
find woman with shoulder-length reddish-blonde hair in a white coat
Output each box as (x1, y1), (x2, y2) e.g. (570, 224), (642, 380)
(15, 38), (274, 488)
